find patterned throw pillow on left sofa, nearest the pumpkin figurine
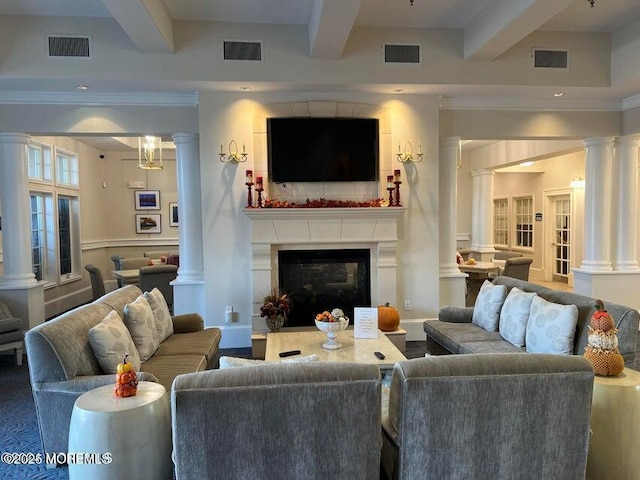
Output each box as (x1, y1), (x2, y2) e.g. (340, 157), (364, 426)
(89, 310), (140, 373)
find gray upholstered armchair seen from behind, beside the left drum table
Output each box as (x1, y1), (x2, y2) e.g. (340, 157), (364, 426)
(171, 362), (381, 480)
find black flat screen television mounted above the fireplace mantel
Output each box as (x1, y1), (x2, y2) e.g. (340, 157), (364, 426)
(267, 118), (379, 183)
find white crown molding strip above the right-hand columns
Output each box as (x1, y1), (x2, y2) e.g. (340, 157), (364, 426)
(440, 97), (624, 112)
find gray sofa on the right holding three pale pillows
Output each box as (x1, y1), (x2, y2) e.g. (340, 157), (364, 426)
(424, 276), (639, 367)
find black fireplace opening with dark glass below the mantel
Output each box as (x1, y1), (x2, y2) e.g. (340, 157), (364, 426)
(278, 249), (371, 327)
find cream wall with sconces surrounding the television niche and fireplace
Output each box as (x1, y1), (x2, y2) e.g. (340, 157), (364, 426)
(200, 93), (439, 345)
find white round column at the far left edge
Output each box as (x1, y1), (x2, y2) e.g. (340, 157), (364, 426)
(0, 133), (36, 286)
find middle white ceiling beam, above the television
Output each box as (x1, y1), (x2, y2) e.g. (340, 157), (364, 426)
(309, 0), (361, 59)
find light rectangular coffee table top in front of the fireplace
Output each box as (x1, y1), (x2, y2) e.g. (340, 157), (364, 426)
(265, 328), (407, 370)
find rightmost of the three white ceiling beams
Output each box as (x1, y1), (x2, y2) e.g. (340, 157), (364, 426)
(464, 0), (574, 60)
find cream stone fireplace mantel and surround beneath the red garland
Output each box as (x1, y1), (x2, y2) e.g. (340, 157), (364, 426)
(244, 207), (406, 332)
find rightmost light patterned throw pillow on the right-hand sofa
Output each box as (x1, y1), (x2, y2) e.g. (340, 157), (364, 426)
(525, 296), (578, 355)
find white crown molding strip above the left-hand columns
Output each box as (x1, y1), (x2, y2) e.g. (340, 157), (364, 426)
(0, 91), (198, 107)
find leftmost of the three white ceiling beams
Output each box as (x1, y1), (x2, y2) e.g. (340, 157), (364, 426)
(102, 0), (173, 53)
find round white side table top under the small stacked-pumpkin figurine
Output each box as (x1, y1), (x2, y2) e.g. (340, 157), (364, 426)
(74, 382), (167, 413)
